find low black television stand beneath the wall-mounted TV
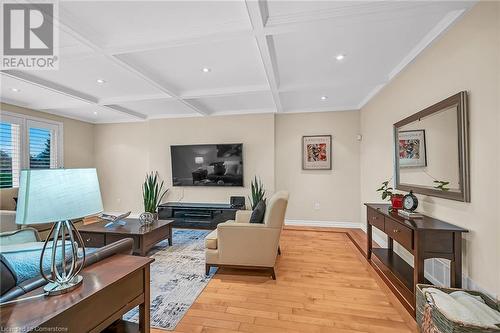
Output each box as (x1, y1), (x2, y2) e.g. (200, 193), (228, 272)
(158, 202), (241, 229)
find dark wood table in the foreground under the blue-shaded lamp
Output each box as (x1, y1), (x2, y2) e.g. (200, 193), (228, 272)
(0, 254), (154, 333)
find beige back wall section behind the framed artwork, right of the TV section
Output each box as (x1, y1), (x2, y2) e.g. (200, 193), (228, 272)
(276, 111), (360, 227)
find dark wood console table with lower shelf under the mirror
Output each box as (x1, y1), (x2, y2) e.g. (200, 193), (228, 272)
(365, 203), (467, 316)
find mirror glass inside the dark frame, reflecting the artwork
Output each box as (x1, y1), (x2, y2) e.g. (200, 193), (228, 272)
(396, 105), (460, 192)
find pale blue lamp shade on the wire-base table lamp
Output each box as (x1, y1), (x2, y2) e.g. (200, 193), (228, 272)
(16, 169), (103, 224)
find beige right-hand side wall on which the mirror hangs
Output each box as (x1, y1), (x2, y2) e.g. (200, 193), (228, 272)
(360, 2), (500, 295)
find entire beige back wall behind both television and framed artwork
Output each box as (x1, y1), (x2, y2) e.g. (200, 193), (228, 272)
(94, 111), (360, 226)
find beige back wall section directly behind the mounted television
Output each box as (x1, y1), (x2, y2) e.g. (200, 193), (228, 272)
(95, 114), (274, 212)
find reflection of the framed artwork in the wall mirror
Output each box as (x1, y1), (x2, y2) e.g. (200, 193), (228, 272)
(398, 130), (427, 168)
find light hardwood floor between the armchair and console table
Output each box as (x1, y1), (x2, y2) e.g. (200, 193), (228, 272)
(152, 228), (417, 333)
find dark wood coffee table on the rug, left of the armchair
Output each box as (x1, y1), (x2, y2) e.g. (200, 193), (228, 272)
(78, 218), (174, 256)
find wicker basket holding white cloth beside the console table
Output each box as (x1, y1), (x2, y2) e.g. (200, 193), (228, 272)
(416, 284), (500, 333)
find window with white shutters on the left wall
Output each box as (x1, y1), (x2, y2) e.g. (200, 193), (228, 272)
(0, 111), (62, 188)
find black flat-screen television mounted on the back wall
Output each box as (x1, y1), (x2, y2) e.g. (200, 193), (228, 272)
(170, 143), (243, 186)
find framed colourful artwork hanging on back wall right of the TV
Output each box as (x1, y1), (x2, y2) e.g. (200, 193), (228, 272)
(302, 135), (332, 170)
